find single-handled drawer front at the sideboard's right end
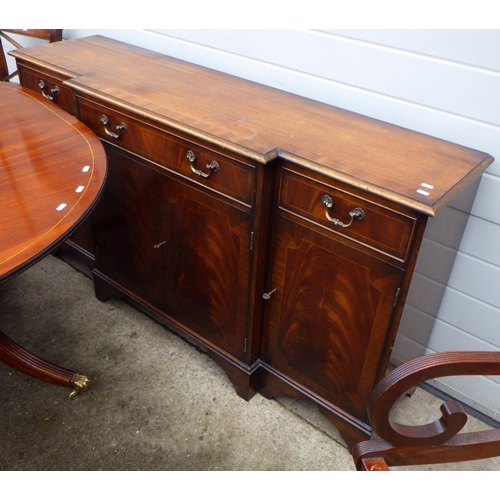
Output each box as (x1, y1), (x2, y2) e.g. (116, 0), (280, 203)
(280, 169), (416, 262)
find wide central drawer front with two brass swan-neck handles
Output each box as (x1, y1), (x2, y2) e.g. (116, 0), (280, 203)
(77, 97), (255, 207)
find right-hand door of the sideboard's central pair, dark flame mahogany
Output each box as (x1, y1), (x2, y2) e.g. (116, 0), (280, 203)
(158, 176), (253, 360)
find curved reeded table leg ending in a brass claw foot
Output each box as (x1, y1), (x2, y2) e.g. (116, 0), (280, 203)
(0, 331), (90, 399)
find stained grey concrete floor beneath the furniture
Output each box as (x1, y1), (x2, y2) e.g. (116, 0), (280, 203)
(0, 252), (500, 471)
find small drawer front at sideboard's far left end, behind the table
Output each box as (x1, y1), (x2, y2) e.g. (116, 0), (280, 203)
(19, 64), (76, 115)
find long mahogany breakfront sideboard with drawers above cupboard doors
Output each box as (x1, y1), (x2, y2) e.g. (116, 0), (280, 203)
(12, 36), (493, 445)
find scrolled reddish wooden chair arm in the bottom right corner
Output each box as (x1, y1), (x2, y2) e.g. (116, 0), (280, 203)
(352, 351), (500, 468)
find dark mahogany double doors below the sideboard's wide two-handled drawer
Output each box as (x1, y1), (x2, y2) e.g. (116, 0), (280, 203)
(93, 146), (253, 360)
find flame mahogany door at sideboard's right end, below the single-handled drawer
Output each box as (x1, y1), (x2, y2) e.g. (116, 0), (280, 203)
(264, 216), (404, 419)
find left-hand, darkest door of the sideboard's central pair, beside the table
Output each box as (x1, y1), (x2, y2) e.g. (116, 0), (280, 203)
(92, 147), (163, 307)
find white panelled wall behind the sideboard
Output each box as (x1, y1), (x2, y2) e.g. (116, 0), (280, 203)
(51, 29), (500, 421)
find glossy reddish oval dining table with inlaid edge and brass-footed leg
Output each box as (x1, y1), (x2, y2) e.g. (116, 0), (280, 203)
(0, 82), (106, 397)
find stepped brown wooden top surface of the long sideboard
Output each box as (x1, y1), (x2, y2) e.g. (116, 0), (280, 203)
(11, 36), (493, 216)
